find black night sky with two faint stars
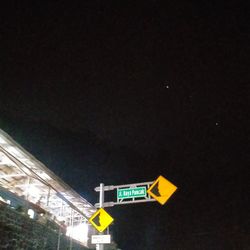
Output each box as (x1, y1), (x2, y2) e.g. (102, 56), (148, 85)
(0, 0), (250, 250)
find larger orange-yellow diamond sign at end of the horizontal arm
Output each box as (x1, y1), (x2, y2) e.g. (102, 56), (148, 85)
(147, 175), (177, 205)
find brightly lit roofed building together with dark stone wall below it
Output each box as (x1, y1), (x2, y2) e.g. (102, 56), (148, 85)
(0, 130), (96, 249)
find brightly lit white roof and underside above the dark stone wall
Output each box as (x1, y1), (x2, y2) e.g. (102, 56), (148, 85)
(0, 130), (96, 246)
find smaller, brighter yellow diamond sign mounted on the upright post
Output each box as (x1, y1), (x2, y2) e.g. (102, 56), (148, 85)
(89, 208), (114, 232)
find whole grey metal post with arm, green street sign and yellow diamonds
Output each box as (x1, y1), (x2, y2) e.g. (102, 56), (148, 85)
(89, 175), (177, 250)
